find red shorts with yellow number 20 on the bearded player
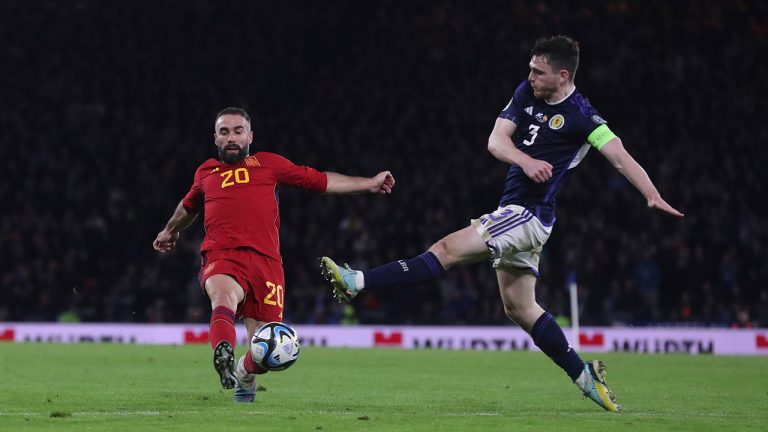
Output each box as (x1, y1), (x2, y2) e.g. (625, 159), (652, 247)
(199, 248), (285, 322)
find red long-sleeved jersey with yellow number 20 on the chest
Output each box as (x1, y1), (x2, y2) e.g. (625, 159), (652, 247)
(182, 152), (328, 262)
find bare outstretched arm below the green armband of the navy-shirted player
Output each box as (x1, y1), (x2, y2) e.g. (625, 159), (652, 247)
(600, 138), (684, 217)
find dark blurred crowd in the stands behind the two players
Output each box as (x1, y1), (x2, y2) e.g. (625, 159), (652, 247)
(0, 0), (768, 327)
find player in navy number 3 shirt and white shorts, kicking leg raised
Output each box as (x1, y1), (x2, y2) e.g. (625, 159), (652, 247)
(321, 36), (683, 412)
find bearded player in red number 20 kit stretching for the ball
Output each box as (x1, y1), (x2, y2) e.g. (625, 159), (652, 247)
(153, 108), (395, 402)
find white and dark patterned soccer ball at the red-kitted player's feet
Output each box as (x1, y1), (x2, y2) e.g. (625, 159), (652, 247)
(251, 322), (301, 372)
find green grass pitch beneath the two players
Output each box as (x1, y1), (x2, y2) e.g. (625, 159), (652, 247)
(0, 343), (768, 432)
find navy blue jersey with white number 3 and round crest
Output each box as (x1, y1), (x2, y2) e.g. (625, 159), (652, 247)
(499, 81), (607, 225)
